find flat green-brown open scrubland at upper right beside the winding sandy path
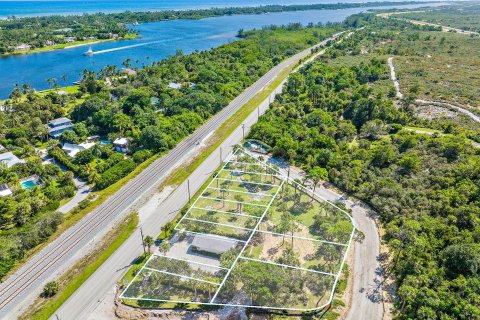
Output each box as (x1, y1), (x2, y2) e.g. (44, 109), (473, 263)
(385, 31), (480, 107)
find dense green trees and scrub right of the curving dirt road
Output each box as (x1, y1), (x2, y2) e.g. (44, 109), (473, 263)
(249, 14), (480, 319)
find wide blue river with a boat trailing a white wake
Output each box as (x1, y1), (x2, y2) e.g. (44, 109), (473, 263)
(0, 0), (444, 99)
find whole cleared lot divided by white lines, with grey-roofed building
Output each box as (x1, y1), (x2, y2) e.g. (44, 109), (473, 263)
(122, 150), (354, 311)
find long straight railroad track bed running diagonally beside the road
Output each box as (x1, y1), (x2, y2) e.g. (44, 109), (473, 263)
(0, 37), (332, 315)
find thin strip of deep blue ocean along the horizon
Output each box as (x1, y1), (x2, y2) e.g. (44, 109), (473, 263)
(0, 0), (436, 18)
